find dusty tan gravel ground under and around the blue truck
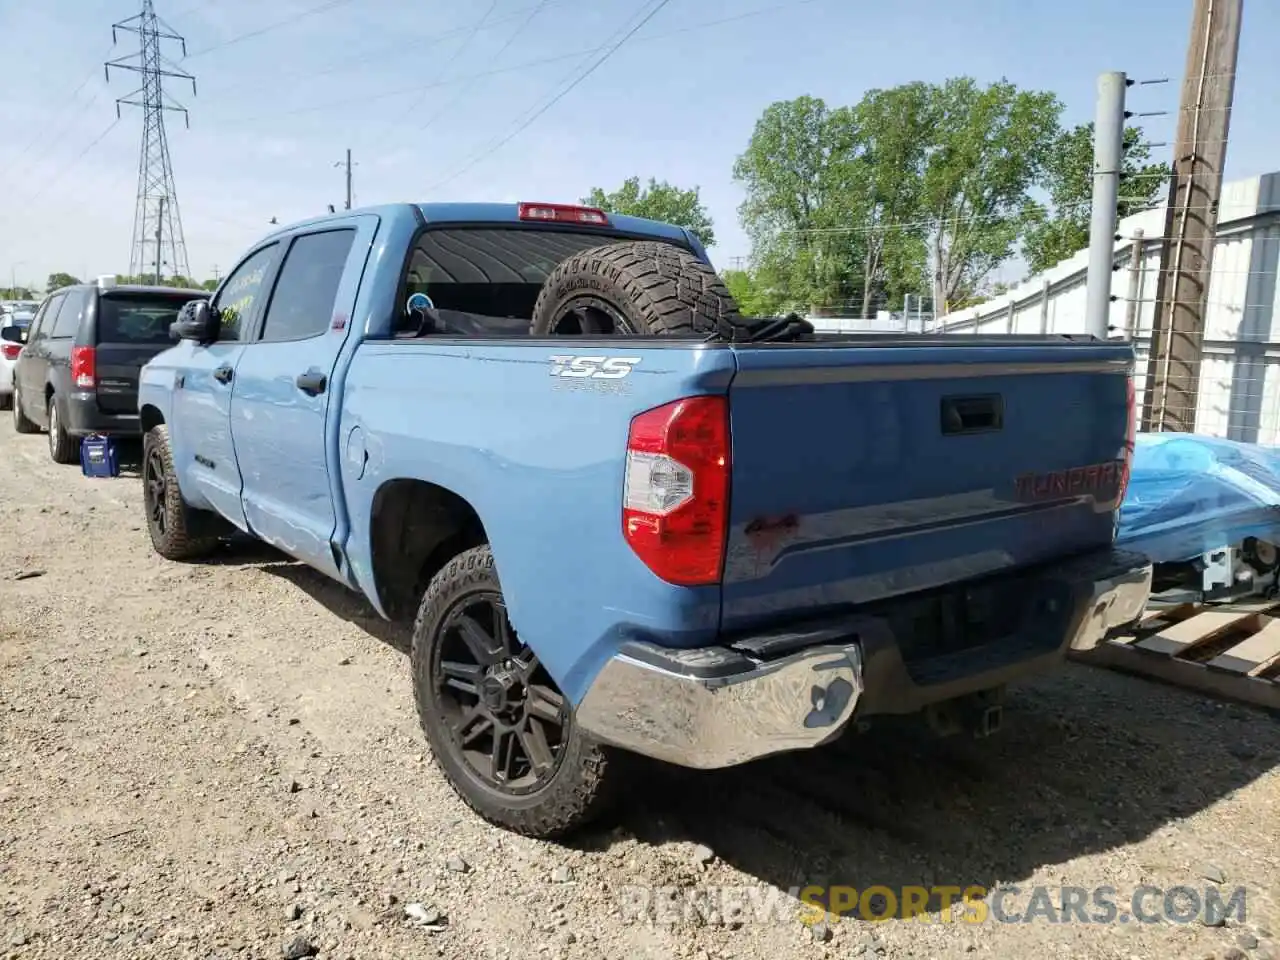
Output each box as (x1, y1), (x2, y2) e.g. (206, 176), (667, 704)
(0, 426), (1280, 960)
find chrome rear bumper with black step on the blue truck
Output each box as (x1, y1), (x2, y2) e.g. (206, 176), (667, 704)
(577, 550), (1151, 768)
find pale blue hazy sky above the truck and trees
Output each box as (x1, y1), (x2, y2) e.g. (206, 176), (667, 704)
(0, 0), (1280, 287)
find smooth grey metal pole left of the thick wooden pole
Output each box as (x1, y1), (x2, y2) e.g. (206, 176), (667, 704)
(1084, 72), (1128, 340)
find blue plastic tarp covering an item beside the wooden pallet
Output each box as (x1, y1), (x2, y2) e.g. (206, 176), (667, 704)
(1117, 433), (1280, 563)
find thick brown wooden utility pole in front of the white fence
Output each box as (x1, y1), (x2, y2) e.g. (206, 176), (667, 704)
(1142, 0), (1244, 431)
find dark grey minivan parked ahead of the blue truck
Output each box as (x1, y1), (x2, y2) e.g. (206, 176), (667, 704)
(13, 282), (209, 463)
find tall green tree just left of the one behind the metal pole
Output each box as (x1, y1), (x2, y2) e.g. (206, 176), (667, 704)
(920, 77), (1062, 312)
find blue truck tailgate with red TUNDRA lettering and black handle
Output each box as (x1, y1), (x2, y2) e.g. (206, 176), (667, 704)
(722, 338), (1133, 630)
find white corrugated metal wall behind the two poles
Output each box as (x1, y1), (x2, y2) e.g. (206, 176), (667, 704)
(936, 173), (1280, 444)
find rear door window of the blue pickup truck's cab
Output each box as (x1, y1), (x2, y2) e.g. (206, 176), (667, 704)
(261, 230), (356, 340)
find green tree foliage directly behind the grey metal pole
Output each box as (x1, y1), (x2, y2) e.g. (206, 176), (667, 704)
(1023, 123), (1167, 274)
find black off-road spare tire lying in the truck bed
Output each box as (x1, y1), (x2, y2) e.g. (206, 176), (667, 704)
(530, 241), (742, 337)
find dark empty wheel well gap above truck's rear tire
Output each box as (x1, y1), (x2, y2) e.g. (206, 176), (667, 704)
(370, 480), (489, 621)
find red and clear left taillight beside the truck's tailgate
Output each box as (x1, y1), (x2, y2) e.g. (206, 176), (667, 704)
(622, 397), (730, 586)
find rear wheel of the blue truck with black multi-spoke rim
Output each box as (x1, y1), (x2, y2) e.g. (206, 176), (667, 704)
(411, 545), (621, 840)
